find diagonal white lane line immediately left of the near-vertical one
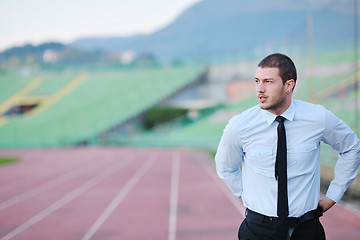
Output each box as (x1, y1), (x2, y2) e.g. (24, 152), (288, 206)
(82, 158), (155, 240)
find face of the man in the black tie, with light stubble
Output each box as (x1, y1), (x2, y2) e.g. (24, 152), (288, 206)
(255, 67), (291, 115)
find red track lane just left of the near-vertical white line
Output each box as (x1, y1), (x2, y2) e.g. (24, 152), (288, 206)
(87, 150), (172, 240)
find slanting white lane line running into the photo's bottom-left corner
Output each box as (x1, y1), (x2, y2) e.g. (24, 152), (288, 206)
(1, 158), (130, 240)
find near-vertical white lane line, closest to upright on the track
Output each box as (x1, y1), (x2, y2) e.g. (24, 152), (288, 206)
(168, 155), (180, 240)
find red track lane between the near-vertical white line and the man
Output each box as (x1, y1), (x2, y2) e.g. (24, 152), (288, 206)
(176, 152), (243, 240)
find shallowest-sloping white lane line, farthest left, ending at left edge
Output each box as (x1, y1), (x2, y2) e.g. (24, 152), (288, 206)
(0, 158), (113, 211)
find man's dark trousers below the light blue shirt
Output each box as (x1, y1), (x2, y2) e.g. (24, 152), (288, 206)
(238, 209), (326, 240)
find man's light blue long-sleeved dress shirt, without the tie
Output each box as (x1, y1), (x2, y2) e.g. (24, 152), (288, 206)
(215, 100), (360, 217)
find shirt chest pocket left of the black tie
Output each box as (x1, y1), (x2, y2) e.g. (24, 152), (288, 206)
(246, 147), (275, 177)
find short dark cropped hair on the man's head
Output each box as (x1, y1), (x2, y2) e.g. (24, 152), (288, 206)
(258, 53), (297, 84)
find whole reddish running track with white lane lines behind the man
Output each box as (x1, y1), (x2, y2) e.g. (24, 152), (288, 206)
(0, 148), (360, 240)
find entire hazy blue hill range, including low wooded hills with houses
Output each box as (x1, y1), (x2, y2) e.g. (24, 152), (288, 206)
(0, 0), (360, 68)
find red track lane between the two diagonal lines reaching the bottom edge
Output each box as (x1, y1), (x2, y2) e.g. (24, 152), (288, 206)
(11, 152), (142, 240)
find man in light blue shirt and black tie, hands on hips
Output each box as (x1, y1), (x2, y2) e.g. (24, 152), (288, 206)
(215, 53), (360, 240)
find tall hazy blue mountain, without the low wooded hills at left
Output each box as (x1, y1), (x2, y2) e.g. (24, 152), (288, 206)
(71, 0), (353, 62)
